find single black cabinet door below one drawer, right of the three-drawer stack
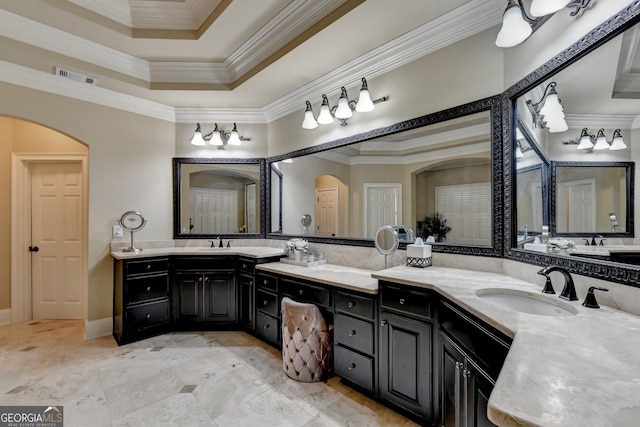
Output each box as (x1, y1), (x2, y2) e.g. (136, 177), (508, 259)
(380, 312), (431, 417)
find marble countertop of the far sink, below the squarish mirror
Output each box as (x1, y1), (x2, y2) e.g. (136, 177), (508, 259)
(111, 246), (285, 259)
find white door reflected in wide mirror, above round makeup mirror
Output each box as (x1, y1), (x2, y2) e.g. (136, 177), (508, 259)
(363, 183), (402, 238)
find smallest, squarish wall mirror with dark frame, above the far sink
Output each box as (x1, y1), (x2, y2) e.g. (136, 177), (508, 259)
(173, 158), (266, 239)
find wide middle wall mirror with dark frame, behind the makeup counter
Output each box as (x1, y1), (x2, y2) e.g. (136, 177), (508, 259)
(267, 96), (502, 256)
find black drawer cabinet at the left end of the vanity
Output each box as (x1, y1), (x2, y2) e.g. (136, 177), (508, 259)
(113, 257), (171, 344)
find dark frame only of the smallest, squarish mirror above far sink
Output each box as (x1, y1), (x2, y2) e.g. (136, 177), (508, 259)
(173, 157), (267, 239)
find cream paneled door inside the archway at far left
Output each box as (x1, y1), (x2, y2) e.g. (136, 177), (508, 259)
(31, 162), (84, 319)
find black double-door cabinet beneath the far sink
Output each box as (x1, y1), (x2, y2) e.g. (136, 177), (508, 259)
(172, 257), (238, 326)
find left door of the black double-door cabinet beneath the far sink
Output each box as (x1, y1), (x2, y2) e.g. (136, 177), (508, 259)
(173, 273), (204, 322)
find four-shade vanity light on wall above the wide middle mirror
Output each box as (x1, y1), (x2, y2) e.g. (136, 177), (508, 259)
(302, 77), (389, 129)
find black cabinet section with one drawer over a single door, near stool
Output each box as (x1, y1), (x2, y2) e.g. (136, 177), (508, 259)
(379, 282), (433, 420)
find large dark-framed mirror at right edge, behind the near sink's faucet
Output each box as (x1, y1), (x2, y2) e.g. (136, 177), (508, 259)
(503, 2), (640, 286)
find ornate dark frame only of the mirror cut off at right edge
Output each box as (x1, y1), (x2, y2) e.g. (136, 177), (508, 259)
(502, 1), (640, 287)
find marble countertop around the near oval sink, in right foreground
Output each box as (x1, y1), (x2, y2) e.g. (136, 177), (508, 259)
(372, 266), (640, 427)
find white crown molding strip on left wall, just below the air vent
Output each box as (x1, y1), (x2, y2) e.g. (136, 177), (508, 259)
(0, 61), (176, 122)
